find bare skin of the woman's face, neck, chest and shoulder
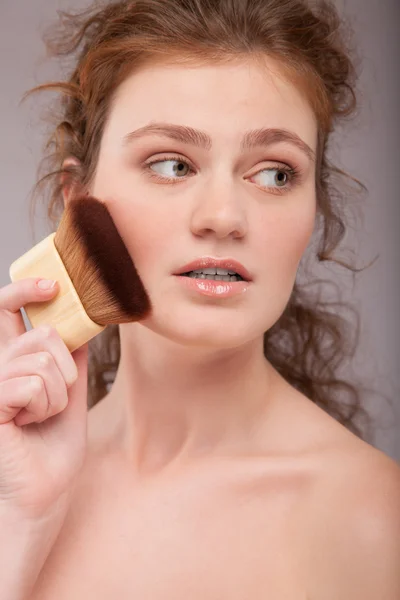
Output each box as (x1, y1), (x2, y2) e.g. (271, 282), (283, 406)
(3, 54), (399, 600)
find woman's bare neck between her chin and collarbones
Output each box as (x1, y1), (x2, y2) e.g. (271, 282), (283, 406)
(88, 325), (279, 474)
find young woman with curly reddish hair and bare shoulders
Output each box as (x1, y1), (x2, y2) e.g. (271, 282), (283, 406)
(0, 0), (400, 600)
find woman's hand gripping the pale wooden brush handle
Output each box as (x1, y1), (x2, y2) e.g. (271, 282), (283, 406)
(0, 278), (88, 521)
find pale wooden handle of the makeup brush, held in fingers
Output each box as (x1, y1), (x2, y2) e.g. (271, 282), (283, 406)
(10, 233), (105, 352)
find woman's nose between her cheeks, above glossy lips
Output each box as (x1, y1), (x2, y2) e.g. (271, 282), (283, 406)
(191, 180), (247, 238)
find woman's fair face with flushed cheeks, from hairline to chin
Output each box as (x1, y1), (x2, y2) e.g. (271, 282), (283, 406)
(90, 59), (317, 349)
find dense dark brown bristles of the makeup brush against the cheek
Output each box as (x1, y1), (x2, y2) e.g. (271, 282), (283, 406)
(54, 196), (150, 325)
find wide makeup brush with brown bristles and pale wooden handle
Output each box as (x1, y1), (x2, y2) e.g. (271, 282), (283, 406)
(10, 195), (150, 352)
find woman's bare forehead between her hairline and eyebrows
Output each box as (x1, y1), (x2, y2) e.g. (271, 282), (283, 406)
(107, 63), (316, 145)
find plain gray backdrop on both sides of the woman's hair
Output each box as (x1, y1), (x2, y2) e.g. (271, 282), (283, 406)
(0, 0), (400, 461)
